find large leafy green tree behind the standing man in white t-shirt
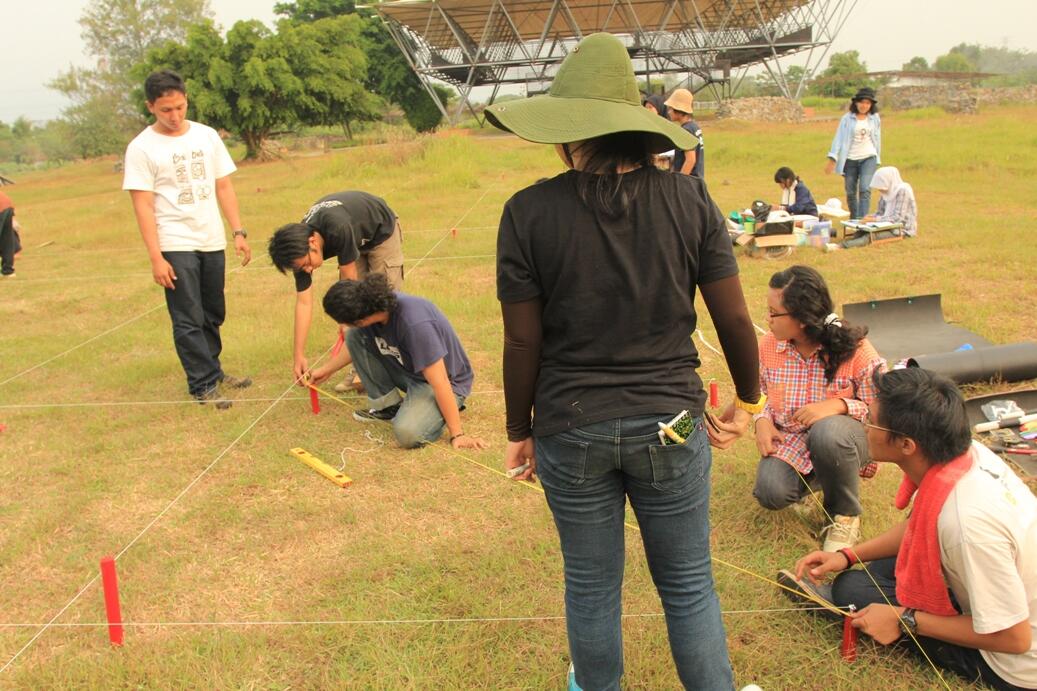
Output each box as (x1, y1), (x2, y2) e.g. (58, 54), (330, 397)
(136, 16), (380, 159)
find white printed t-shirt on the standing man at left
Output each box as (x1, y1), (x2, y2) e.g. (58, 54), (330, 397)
(122, 120), (237, 252)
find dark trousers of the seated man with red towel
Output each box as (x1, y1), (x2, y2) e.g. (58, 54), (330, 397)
(832, 557), (1021, 691)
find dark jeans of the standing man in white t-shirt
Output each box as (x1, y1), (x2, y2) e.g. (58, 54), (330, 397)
(162, 250), (227, 395)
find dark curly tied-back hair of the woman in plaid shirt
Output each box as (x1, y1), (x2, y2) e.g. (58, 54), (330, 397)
(768, 265), (868, 383)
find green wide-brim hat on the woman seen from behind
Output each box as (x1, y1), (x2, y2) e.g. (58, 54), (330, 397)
(485, 33), (699, 154)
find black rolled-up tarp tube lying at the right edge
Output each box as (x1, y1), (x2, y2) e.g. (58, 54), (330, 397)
(907, 341), (1037, 384)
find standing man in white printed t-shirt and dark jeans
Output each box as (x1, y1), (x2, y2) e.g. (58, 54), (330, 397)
(122, 70), (252, 408)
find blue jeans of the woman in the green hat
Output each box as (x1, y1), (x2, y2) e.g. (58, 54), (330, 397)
(535, 413), (734, 691)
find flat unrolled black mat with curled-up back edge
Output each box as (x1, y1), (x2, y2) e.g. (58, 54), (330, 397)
(843, 294), (991, 364)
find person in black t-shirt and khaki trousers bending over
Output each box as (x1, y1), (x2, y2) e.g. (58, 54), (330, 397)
(268, 191), (403, 392)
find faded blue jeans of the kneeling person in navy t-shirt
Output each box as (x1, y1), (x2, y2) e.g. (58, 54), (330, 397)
(345, 329), (465, 448)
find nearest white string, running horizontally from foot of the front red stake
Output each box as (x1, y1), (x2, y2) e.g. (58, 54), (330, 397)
(0, 606), (826, 629)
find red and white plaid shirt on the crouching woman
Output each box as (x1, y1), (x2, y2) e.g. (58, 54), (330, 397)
(760, 332), (886, 477)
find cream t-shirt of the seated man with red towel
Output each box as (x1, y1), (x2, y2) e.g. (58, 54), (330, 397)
(936, 442), (1037, 689)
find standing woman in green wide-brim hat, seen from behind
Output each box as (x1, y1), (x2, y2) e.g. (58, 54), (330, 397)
(486, 33), (760, 690)
